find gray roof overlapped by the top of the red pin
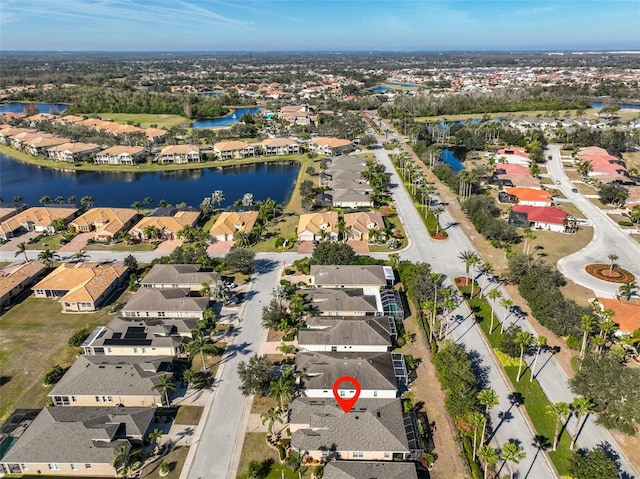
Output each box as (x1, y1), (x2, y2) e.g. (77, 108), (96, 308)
(296, 352), (398, 391)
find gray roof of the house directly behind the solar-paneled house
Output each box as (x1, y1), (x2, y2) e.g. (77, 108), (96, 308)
(122, 288), (209, 314)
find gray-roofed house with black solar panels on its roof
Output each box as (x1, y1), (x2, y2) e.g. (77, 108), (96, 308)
(82, 318), (190, 356)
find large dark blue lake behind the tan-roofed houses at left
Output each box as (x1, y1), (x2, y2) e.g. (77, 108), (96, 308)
(0, 154), (300, 207)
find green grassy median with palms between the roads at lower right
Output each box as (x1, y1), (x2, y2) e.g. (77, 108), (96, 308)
(458, 285), (573, 476)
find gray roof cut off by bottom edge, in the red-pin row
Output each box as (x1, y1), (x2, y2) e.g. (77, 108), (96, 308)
(322, 461), (418, 479)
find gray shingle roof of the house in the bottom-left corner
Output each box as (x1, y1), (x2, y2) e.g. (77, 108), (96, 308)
(2, 407), (155, 464)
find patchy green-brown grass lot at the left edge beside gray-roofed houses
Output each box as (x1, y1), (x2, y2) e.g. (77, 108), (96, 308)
(0, 293), (126, 421)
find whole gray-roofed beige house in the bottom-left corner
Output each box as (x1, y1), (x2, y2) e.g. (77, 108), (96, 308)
(0, 407), (156, 477)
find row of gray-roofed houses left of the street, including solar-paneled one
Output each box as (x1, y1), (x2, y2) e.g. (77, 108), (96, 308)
(0, 265), (217, 477)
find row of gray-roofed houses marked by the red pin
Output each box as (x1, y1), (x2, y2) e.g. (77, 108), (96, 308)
(288, 266), (424, 479)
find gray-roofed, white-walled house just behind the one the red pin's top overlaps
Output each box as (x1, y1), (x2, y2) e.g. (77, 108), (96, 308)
(298, 316), (398, 353)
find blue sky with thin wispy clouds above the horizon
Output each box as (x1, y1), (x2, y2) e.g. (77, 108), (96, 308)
(0, 0), (640, 51)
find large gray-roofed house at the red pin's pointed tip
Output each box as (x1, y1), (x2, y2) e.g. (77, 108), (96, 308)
(289, 397), (423, 461)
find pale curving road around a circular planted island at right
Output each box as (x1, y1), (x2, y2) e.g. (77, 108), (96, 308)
(547, 145), (640, 297)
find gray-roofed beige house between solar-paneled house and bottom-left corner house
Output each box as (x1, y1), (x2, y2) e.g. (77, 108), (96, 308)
(48, 354), (173, 407)
